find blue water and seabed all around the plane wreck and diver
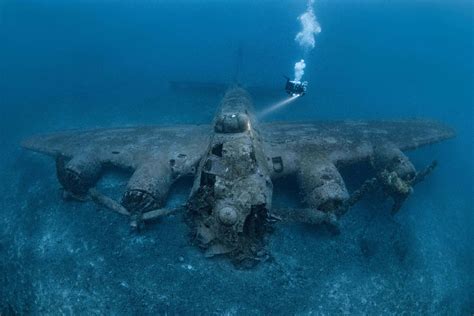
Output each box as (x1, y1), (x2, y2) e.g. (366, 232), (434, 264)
(0, 0), (474, 315)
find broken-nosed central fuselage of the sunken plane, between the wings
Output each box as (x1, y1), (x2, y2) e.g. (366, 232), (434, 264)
(189, 88), (273, 255)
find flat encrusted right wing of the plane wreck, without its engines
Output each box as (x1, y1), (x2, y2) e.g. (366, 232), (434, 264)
(261, 120), (455, 173)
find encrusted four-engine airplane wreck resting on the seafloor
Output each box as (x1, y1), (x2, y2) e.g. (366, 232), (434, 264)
(23, 87), (454, 264)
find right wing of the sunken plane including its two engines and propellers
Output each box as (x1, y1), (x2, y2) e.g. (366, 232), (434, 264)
(262, 120), (455, 216)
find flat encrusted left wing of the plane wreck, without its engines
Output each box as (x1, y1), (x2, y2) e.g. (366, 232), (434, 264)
(22, 125), (211, 169)
